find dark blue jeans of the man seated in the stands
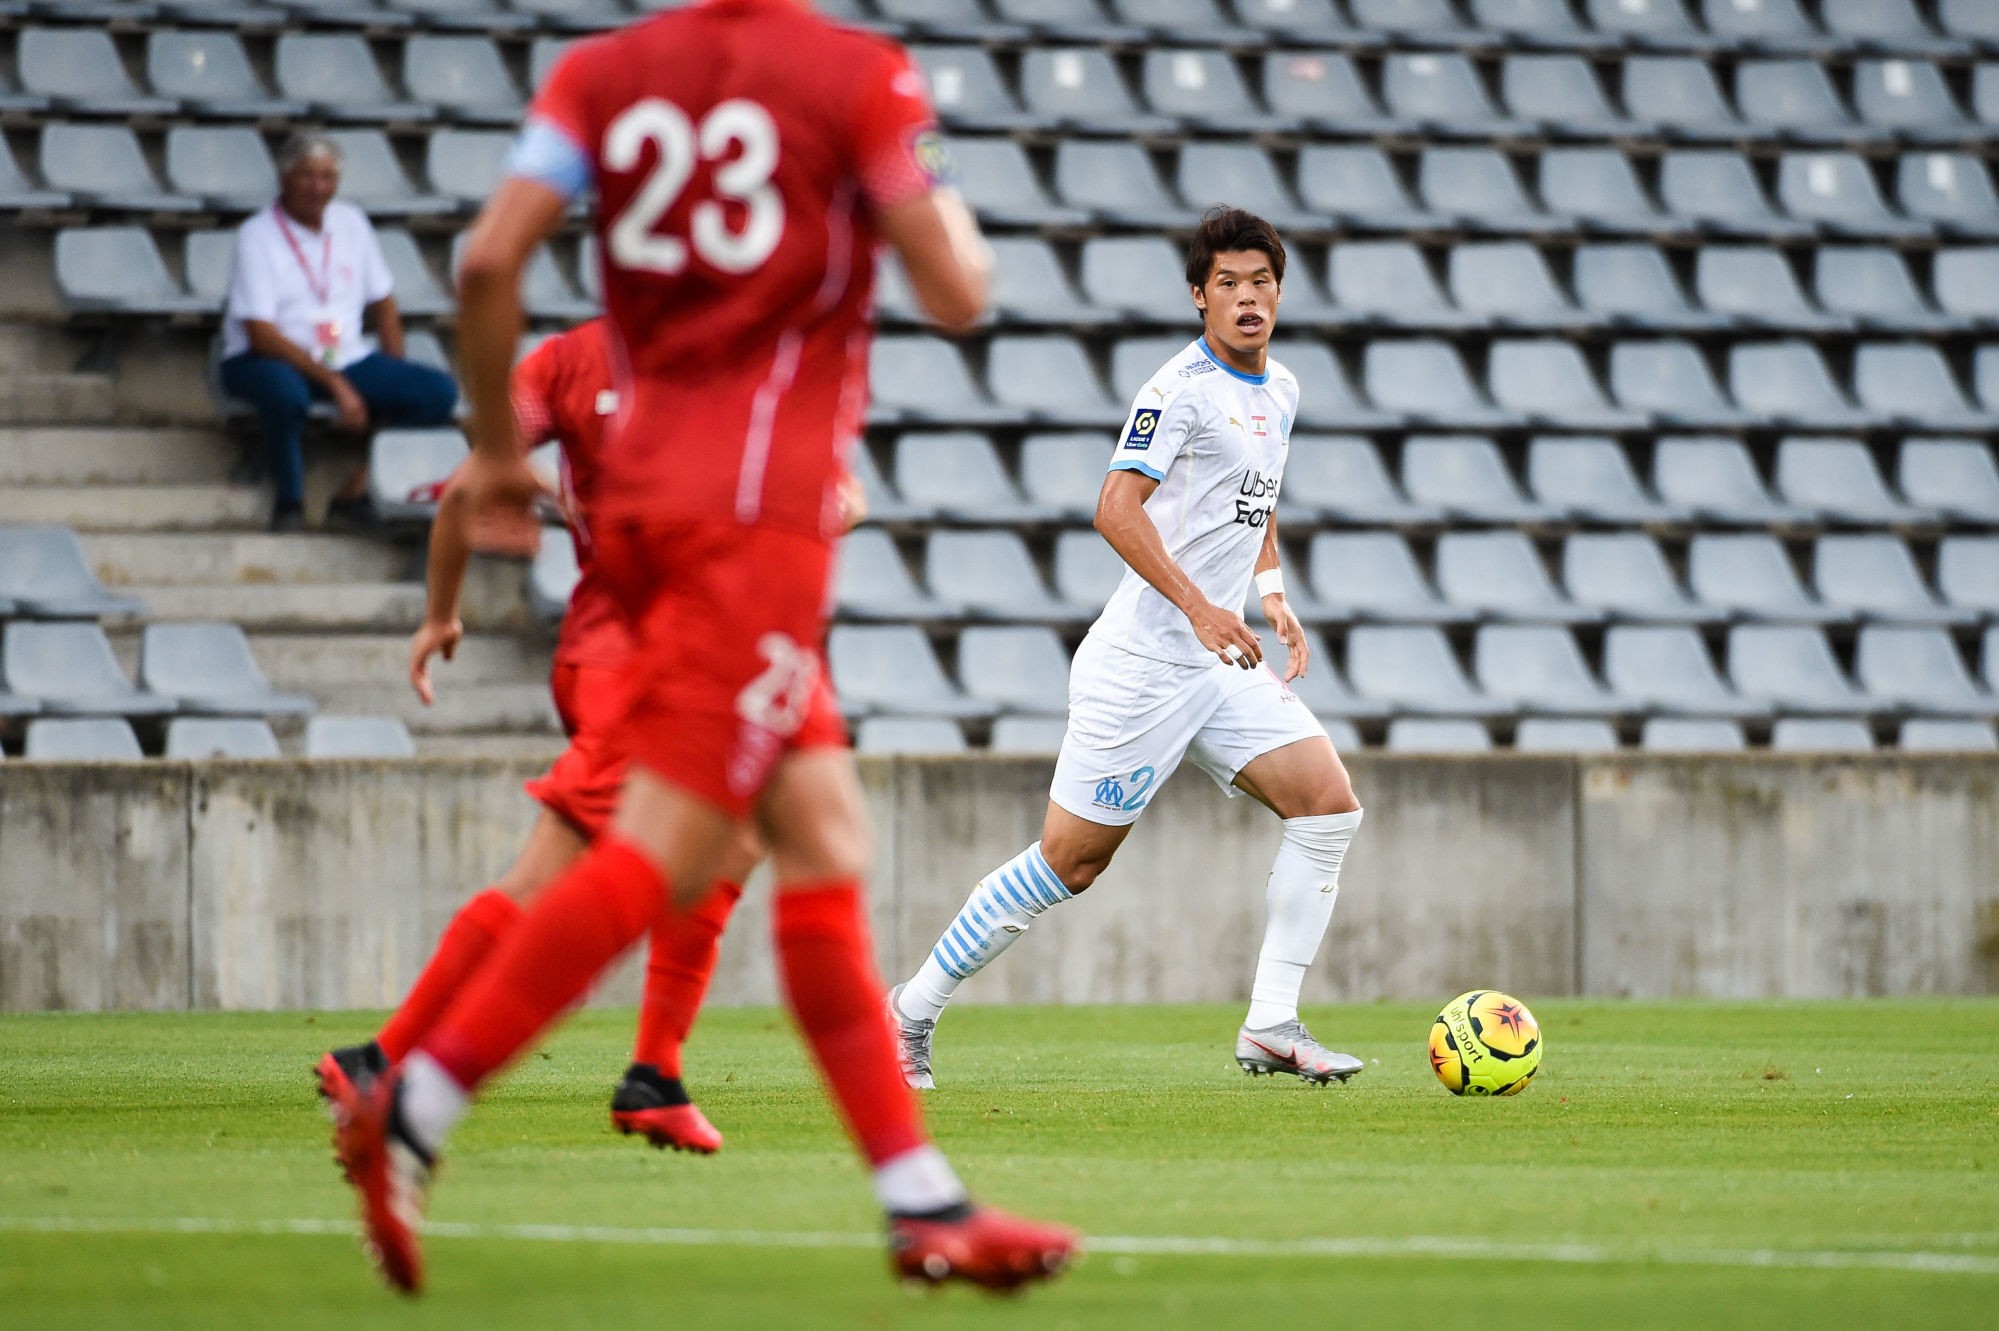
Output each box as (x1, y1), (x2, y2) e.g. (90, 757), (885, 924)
(222, 352), (458, 506)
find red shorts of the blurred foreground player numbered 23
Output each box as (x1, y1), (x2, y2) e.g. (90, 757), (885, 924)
(598, 520), (848, 817)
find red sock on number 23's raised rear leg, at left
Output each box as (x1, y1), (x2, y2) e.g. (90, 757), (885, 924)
(422, 835), (666, 1091)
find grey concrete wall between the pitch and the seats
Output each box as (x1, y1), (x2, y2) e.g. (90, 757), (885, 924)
(0, 755), (1999, 1009)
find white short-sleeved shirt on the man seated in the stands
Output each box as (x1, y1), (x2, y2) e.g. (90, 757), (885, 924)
(222, 200), (394, 370)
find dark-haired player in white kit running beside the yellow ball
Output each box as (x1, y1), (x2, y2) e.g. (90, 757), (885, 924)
(888, 208), (1361, 1089)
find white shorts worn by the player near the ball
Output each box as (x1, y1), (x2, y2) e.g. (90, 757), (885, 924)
(1047, 636), (1325, 827)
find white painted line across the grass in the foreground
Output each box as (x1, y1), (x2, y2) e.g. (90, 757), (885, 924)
(0, 1215), (1999, 1275)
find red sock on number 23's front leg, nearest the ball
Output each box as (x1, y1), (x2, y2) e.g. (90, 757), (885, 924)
(772, 877), (930, 1165)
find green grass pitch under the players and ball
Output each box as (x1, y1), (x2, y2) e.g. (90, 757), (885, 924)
(0, 995), (1999, 1331)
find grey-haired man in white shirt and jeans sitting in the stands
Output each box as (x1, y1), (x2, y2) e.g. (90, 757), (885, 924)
(222, 134), (458, 532)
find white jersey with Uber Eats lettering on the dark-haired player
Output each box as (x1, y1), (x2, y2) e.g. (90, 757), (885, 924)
(1089, 338), (1297, 666)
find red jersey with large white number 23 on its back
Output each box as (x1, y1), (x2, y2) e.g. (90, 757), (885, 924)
(530, 0), (938, 538)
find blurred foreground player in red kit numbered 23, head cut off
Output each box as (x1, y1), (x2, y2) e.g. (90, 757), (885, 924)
(338, 0), (1077, 1291)
